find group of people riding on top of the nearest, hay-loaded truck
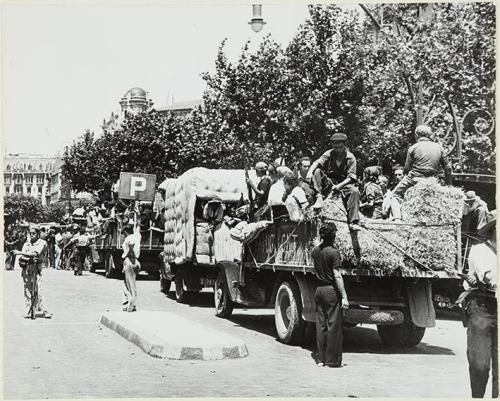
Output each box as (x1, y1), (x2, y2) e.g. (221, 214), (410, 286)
(247, 125), (458, 231)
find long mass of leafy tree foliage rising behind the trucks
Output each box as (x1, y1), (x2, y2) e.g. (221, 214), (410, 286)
(63, 3), (495, 192)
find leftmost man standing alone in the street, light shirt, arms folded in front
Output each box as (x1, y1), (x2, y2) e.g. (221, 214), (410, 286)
(16, 227), (52, 319)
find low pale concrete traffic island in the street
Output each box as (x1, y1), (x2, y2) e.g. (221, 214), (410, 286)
(100, 311), (248, 361)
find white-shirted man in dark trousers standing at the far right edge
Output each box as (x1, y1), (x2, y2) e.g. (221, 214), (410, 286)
(457, 210), (498, 398)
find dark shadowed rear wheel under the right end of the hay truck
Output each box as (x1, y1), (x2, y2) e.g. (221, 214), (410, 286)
(377, 312), (425, 348)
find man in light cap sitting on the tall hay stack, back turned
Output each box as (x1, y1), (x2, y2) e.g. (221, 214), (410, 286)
(394, 125), (451, 203)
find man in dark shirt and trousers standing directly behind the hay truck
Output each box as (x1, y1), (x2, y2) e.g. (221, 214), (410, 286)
(312, 222), (349, 368)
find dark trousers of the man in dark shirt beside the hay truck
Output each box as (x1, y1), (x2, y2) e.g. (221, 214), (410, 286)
(314, 285), (343, 366)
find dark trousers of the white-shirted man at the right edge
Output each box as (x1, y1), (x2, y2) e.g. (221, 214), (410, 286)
(467, 298), (498, 398)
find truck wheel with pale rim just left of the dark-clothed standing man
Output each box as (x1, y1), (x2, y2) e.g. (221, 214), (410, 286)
(274, 281), (306, 344)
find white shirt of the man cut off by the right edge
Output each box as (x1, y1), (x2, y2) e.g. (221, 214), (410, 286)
(469, 243), (497, 293)
